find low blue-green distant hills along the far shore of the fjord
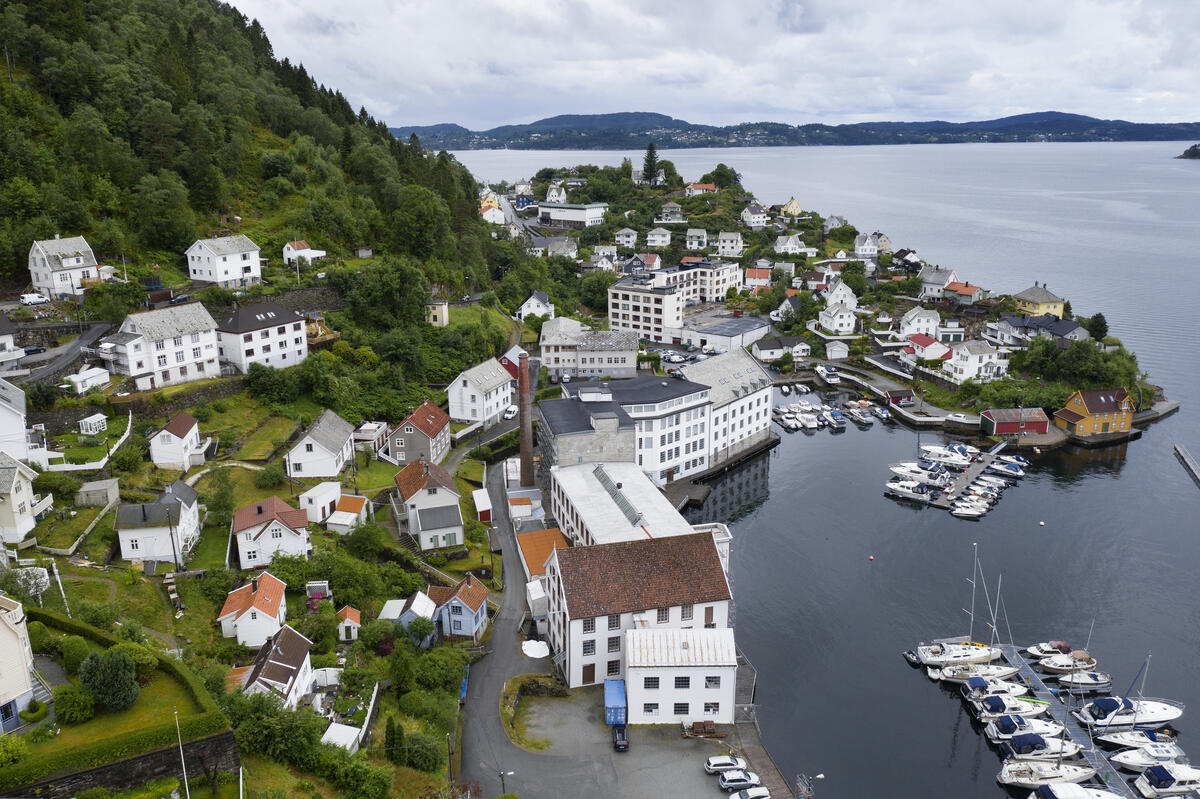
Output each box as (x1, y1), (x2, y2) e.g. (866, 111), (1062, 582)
(390, 112), (1200, 150)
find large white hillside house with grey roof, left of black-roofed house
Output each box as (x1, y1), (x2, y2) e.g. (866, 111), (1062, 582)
(96, 302), (221, 391)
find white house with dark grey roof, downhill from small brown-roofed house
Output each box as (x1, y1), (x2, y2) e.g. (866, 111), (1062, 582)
(115, 480), (200, 567)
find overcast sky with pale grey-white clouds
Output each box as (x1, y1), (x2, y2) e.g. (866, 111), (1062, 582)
(234, 0), (1200, 130)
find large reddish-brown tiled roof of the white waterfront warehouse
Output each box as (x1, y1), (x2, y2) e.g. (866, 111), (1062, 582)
(554, 533), (731, 619)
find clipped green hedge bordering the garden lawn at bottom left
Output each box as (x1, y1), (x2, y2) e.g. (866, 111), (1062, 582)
(0, 607), (229, 791)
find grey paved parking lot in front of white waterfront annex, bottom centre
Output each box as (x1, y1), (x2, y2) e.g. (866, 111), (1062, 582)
(522, 686), (728, 799)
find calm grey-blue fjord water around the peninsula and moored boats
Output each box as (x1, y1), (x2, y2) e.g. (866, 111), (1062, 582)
(456, 143), (1200, 799)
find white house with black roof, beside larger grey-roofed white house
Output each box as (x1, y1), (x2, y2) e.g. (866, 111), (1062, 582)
(217, 302), (308, 374)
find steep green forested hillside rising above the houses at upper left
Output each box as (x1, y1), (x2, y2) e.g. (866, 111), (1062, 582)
(0, 0), (490, 287)
